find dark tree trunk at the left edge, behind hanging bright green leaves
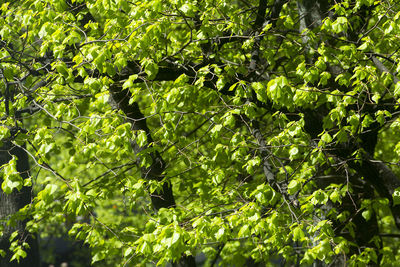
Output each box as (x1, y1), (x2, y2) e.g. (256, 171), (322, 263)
(0, 141), (40, 267)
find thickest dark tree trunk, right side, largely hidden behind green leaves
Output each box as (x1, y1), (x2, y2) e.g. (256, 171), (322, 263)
(297, 0), (382, 266)
